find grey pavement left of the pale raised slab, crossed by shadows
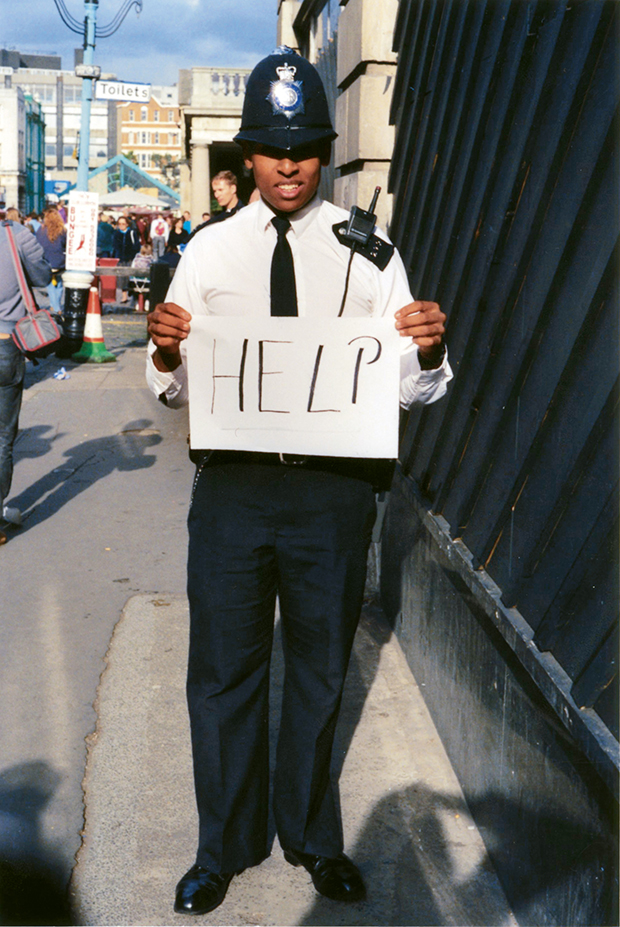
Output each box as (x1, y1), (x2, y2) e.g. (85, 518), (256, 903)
(0, 315), (193, 924)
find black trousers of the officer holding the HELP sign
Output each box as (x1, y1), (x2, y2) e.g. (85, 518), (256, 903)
(187, 464), (375, 872)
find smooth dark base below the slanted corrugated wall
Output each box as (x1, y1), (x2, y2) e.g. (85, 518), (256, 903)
(381, 474), (618, 927)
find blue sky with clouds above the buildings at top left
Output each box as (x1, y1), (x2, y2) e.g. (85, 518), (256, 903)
(0, 0), (277, 85)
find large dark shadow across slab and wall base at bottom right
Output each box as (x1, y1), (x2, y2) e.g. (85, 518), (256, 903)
(300, 785), (616, 927)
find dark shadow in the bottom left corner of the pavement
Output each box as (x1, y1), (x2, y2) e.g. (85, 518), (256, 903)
(0, 761), (75, 925)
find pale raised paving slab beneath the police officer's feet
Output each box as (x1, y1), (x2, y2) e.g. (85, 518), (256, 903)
(71, 594), (516, 927)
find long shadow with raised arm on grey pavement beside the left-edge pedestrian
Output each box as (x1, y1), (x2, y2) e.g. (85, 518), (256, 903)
(11, 419), (162, 531)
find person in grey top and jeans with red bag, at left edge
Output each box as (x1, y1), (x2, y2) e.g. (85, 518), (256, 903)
(0, 214), (52, 544)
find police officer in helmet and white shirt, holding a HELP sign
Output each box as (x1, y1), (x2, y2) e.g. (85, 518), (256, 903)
(147, 47), (451, 914)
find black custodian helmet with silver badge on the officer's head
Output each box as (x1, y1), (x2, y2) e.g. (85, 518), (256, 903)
(235, 45), (337, 151)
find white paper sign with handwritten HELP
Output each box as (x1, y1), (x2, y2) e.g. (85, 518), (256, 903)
(187, 316), (400, 458)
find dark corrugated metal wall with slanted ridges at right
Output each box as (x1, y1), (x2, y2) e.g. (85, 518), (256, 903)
(390, 0), (619, 735)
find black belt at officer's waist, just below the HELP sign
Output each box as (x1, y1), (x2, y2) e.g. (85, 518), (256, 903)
(190, 450), (395, 492)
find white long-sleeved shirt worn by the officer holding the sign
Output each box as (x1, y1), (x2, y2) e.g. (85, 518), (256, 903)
(147, 196), (452, 408)
